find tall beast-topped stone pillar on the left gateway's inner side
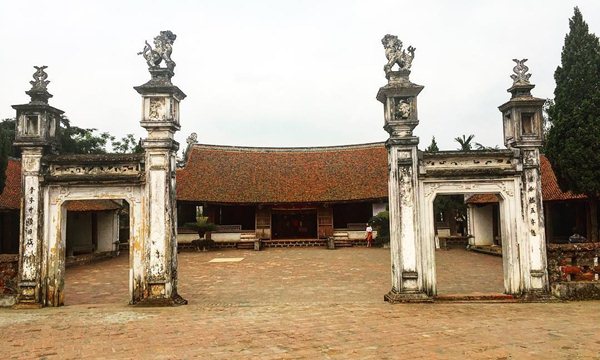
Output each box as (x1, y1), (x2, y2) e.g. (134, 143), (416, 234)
(133, 31), (187, 305)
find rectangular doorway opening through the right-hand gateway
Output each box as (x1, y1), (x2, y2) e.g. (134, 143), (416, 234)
(431, 194), (505, 299)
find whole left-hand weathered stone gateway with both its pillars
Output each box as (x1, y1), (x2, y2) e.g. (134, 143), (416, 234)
(13, 31), (186, 306)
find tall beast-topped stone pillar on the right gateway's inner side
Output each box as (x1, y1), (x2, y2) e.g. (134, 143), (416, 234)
(377, 35), (429, 303)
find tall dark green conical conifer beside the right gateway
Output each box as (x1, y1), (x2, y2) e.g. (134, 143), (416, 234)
(545, 8), (600, 241)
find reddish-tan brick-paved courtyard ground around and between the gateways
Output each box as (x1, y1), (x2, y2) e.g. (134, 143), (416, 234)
(0, 248), (600, 359)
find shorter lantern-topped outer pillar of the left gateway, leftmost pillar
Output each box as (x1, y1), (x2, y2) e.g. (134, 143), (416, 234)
(13, 66), (63, 307)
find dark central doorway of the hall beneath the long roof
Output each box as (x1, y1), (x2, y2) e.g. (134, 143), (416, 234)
(272, 210), (317, 239)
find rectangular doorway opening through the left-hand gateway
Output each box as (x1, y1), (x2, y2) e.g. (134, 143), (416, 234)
(61, 199), (132, 305)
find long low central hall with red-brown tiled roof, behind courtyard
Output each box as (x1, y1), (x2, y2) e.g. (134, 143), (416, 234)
(177, 143), (388, 246)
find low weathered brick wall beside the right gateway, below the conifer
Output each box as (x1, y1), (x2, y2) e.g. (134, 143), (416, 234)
(547, 243), (600, 300)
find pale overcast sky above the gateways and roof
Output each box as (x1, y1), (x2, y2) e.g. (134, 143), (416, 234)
(0, 0), (600, 149)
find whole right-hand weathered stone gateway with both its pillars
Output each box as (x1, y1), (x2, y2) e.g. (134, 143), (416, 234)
(377, 35), (548, 303)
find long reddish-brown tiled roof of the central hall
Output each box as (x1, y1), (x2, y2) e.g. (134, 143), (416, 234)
(177, 143), (388, 204)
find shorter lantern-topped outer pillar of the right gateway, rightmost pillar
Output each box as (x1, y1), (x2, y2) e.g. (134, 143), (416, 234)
(498, 59), (548, 296)
